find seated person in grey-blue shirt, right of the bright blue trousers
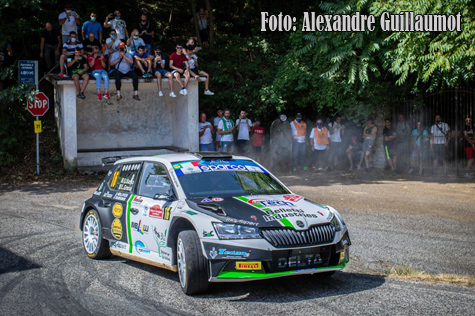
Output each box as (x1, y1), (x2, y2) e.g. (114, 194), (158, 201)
(110, 42), (140, 101)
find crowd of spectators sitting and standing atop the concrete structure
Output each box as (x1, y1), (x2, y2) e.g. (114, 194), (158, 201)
(40, 4), (214, 101)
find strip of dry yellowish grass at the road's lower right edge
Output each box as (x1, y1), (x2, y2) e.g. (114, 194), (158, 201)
(386, 266), (475, 287)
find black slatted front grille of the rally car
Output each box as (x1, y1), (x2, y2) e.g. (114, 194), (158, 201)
(261, 224), (335, 248)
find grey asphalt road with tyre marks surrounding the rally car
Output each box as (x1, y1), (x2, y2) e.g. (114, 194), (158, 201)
(0, 175), (475, 316)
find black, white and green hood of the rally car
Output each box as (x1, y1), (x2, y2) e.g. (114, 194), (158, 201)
(187, 194), (333, 230)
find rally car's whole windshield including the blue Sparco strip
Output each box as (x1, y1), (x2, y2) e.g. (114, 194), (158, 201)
(173, 160), (290, 198)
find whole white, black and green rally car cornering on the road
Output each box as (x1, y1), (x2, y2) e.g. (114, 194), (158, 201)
(79, 152), (351, 294)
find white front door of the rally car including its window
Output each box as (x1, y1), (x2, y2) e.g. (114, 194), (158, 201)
(130, 162), (177, 264)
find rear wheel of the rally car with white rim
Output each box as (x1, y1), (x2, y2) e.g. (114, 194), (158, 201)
(82, 209), (111, 259)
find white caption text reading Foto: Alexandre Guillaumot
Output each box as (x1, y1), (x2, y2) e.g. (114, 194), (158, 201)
(261, 11), (462, 32)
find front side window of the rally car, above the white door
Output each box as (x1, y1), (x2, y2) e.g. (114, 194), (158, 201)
(138, 162), (171, 198)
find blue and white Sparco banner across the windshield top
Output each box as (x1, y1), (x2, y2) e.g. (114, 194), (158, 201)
(173, 159), (268, 176)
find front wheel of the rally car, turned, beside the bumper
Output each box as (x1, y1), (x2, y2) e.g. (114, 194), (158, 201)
(176, 230), (208, 295)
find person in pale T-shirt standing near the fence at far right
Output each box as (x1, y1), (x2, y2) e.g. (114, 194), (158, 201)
(430, 114), (450, 173)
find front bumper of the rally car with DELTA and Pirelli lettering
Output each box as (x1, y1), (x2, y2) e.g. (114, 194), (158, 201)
(203, 232), (351, 282)
